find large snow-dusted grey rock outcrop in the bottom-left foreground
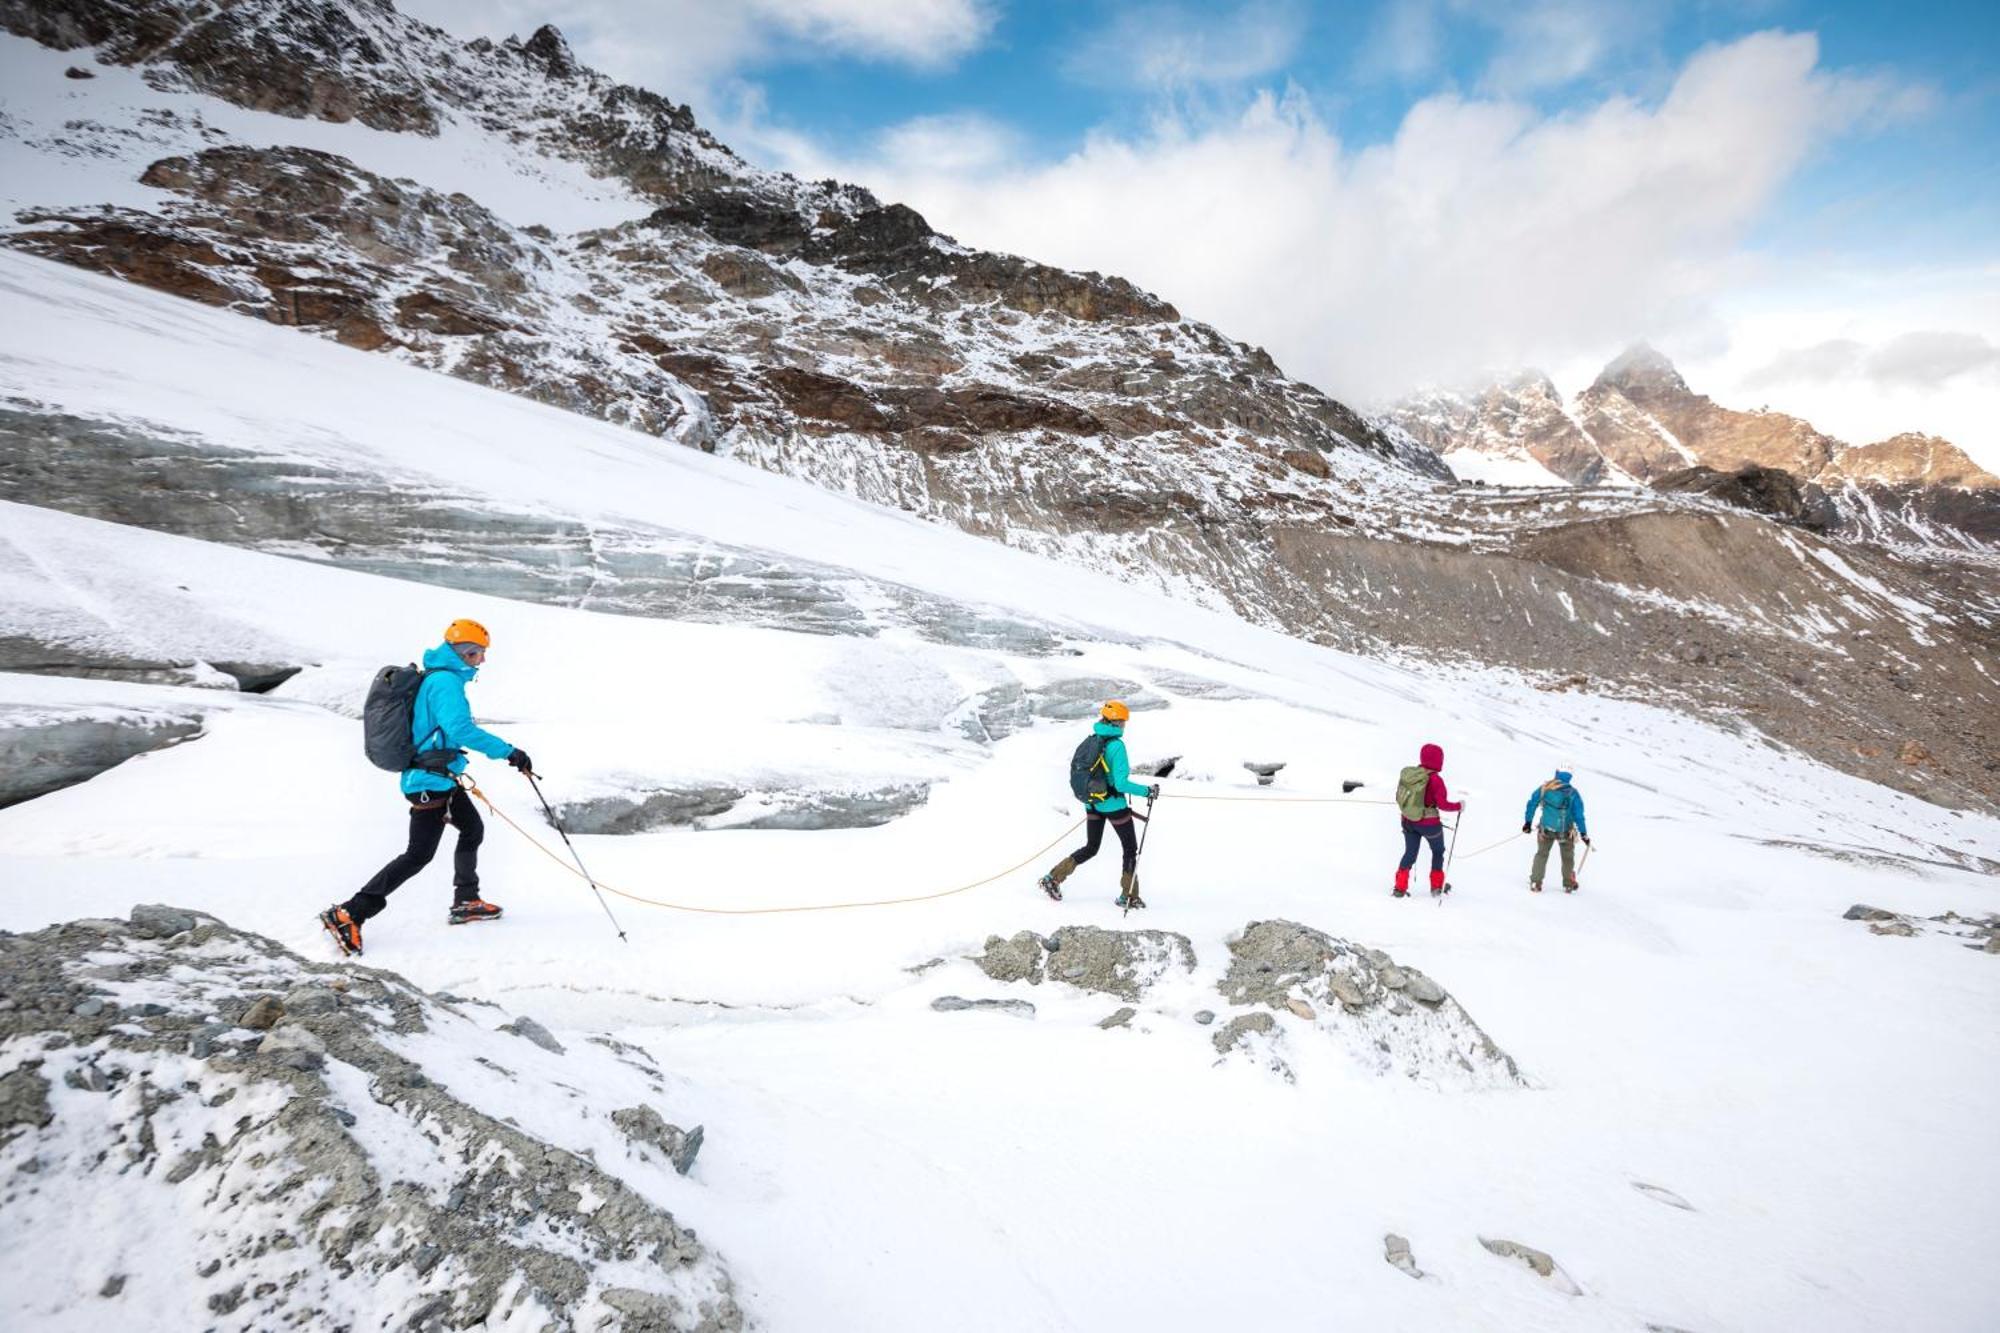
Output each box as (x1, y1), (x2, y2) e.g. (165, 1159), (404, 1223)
(0, 907), (744, 1333)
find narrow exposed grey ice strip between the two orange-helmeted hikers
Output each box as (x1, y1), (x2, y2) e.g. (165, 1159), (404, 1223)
(556, 783), (930, 835)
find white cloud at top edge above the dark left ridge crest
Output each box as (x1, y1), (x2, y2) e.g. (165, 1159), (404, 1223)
(400, 0), (996, 106)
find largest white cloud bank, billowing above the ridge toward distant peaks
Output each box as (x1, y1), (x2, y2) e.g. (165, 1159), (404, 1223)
(772, 32), (1912, 402)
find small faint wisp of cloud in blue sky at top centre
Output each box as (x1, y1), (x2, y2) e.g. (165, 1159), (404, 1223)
(1064, 0), (1306, 90)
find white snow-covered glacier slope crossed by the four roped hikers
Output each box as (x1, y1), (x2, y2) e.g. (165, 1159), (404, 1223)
(0, 244), (2000, 1331)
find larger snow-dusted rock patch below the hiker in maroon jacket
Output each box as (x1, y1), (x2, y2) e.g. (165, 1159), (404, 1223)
(1218, 921), (1522, 1087)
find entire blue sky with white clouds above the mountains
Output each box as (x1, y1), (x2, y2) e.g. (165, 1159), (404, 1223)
(402, 0), (2000, 456)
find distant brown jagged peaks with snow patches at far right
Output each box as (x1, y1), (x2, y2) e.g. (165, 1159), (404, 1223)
(1388, 344), (2000, 548)
